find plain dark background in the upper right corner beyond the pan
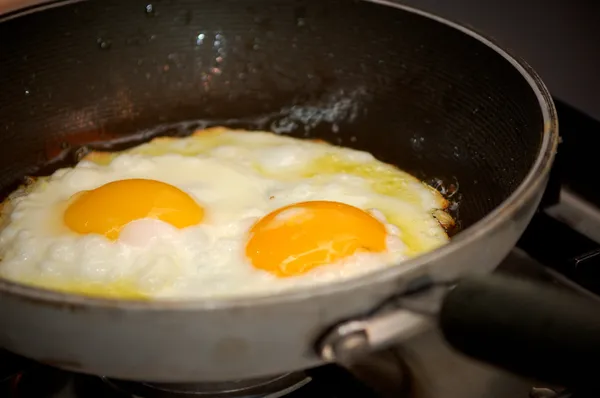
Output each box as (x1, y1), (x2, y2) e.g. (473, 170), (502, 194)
(399, 0), (600, 120)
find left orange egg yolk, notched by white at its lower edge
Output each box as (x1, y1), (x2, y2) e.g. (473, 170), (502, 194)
(64, 179), (204, 240)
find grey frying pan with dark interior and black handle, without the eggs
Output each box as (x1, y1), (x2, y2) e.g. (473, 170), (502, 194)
(0, 0), (600, 392)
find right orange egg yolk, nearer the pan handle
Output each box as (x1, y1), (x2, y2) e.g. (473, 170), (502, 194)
(246, 201), (386, 277)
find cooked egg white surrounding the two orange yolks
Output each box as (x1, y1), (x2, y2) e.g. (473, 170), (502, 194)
(0, 129), (448, 299)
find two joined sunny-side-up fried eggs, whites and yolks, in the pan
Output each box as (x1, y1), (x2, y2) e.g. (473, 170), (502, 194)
(0, 128), (453, 300)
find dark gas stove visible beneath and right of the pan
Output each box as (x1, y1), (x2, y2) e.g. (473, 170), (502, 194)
(0, 100), (600, 398)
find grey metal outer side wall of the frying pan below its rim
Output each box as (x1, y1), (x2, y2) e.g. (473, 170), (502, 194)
(0, 185), (541, 382)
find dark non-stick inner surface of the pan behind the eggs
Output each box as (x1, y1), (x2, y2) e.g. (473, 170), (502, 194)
(0, 0), (543, 230)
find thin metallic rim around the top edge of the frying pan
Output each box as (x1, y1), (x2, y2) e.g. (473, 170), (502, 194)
(0, 0), (559, 311)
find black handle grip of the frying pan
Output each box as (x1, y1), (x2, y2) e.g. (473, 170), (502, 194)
(439, 275), (600, 388)
